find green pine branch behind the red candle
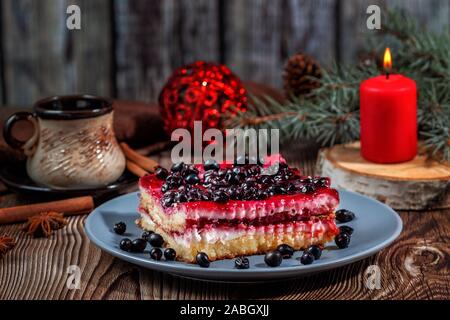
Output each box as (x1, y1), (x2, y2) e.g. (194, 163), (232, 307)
(227, 12), (450, 161)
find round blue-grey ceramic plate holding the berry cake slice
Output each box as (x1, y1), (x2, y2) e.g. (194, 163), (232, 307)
(86, 190), (402, 282)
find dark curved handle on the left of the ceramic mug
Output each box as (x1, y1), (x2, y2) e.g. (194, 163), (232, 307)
(3, 112), (39, 156)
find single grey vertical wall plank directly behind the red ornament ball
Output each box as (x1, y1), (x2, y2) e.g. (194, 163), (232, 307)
(114, 0), (219, 101)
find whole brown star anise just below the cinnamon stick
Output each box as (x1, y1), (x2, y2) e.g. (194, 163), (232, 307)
(23, 211), (67, 238)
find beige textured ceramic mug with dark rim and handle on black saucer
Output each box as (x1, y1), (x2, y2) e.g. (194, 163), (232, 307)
(3, 95), (126, 188)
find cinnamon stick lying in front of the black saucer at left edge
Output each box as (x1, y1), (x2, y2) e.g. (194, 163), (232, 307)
(0, 196), (94, 225)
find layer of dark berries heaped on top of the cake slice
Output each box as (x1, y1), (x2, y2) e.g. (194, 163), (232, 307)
(156, 160), (330, 207)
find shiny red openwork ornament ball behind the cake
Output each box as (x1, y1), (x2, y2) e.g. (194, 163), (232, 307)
(159, 61), (247, 134)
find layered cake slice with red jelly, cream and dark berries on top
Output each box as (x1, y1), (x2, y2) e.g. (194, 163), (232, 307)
(137, 157), (339, 262)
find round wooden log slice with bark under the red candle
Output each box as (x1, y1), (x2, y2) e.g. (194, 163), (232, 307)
(316, 142), (450, 210)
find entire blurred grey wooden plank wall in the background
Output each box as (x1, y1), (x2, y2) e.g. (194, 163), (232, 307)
(0, 0), (450, 106)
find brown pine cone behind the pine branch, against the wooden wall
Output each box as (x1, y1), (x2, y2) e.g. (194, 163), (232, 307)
(283, 53), (322, 97)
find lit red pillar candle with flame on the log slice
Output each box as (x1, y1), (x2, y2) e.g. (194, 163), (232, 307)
(360, 48), (417, 163)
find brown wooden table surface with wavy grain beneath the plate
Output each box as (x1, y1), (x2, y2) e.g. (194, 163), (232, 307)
(0, 147), (450, 299)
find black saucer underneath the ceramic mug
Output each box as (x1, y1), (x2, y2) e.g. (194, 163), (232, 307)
(0, 161), (138, 197)
